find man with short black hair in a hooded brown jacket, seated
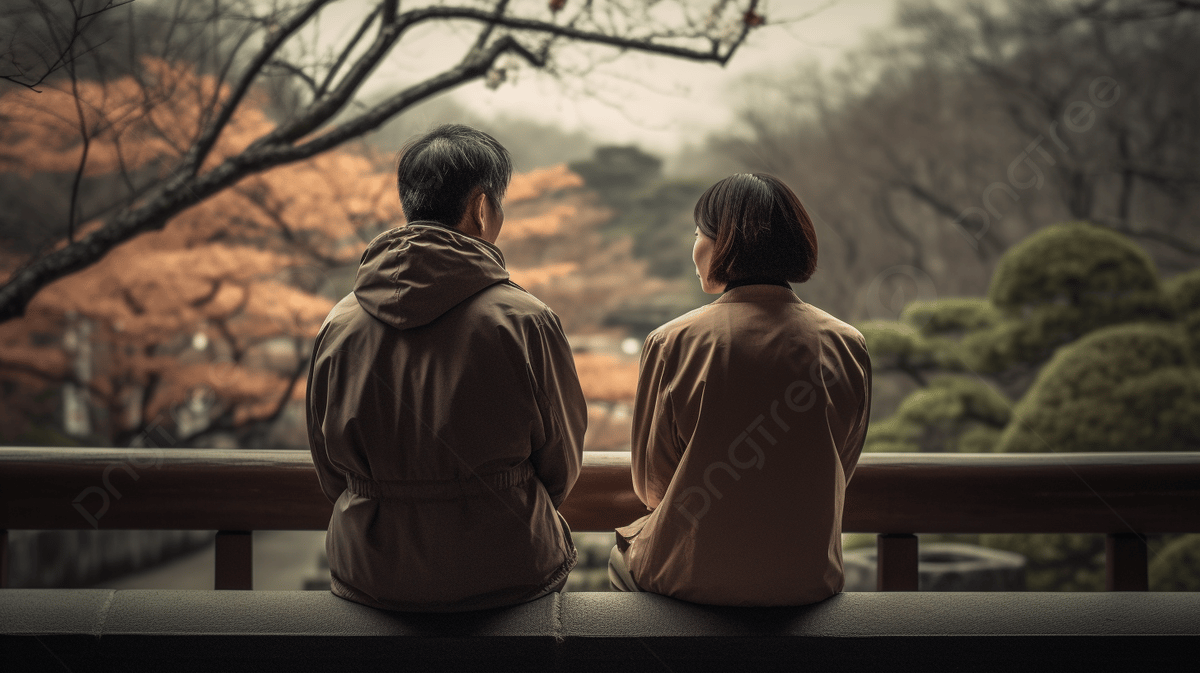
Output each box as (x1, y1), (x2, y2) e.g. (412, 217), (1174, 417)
(307, 125), (587, 612)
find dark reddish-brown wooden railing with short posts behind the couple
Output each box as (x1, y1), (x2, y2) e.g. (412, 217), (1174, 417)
(0, 447), (1200, 590)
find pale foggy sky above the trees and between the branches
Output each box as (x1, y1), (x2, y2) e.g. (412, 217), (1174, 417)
(322, 0), (896, 155)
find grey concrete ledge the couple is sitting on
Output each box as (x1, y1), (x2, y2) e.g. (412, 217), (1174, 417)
(0, 589), (1200, 673)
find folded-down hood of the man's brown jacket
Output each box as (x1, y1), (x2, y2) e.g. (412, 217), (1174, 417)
(354, 222), (509, 330)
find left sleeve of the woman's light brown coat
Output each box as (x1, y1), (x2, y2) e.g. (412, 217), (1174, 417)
(630, 334), (683, 510)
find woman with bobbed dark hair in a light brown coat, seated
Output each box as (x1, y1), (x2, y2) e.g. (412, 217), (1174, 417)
(610, 173), (871, 606)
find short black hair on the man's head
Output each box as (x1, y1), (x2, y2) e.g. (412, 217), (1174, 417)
(396, 124), (512, 227)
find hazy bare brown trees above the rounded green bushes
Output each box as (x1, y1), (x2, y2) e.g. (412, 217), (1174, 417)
(713, 0), (1200, 319)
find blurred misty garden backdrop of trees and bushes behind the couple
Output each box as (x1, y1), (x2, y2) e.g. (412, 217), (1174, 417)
(0, 0), (1200, 590)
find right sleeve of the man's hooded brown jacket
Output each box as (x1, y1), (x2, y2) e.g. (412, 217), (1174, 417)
(529, 314), (588, 507)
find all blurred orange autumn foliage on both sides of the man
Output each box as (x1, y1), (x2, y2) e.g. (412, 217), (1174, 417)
(0, 60), (656, 446)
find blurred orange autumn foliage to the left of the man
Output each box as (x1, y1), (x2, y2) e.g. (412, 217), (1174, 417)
(0, 59), (400, 445)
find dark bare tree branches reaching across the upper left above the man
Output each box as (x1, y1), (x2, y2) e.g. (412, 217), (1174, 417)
(0, 0), (763, 322)
